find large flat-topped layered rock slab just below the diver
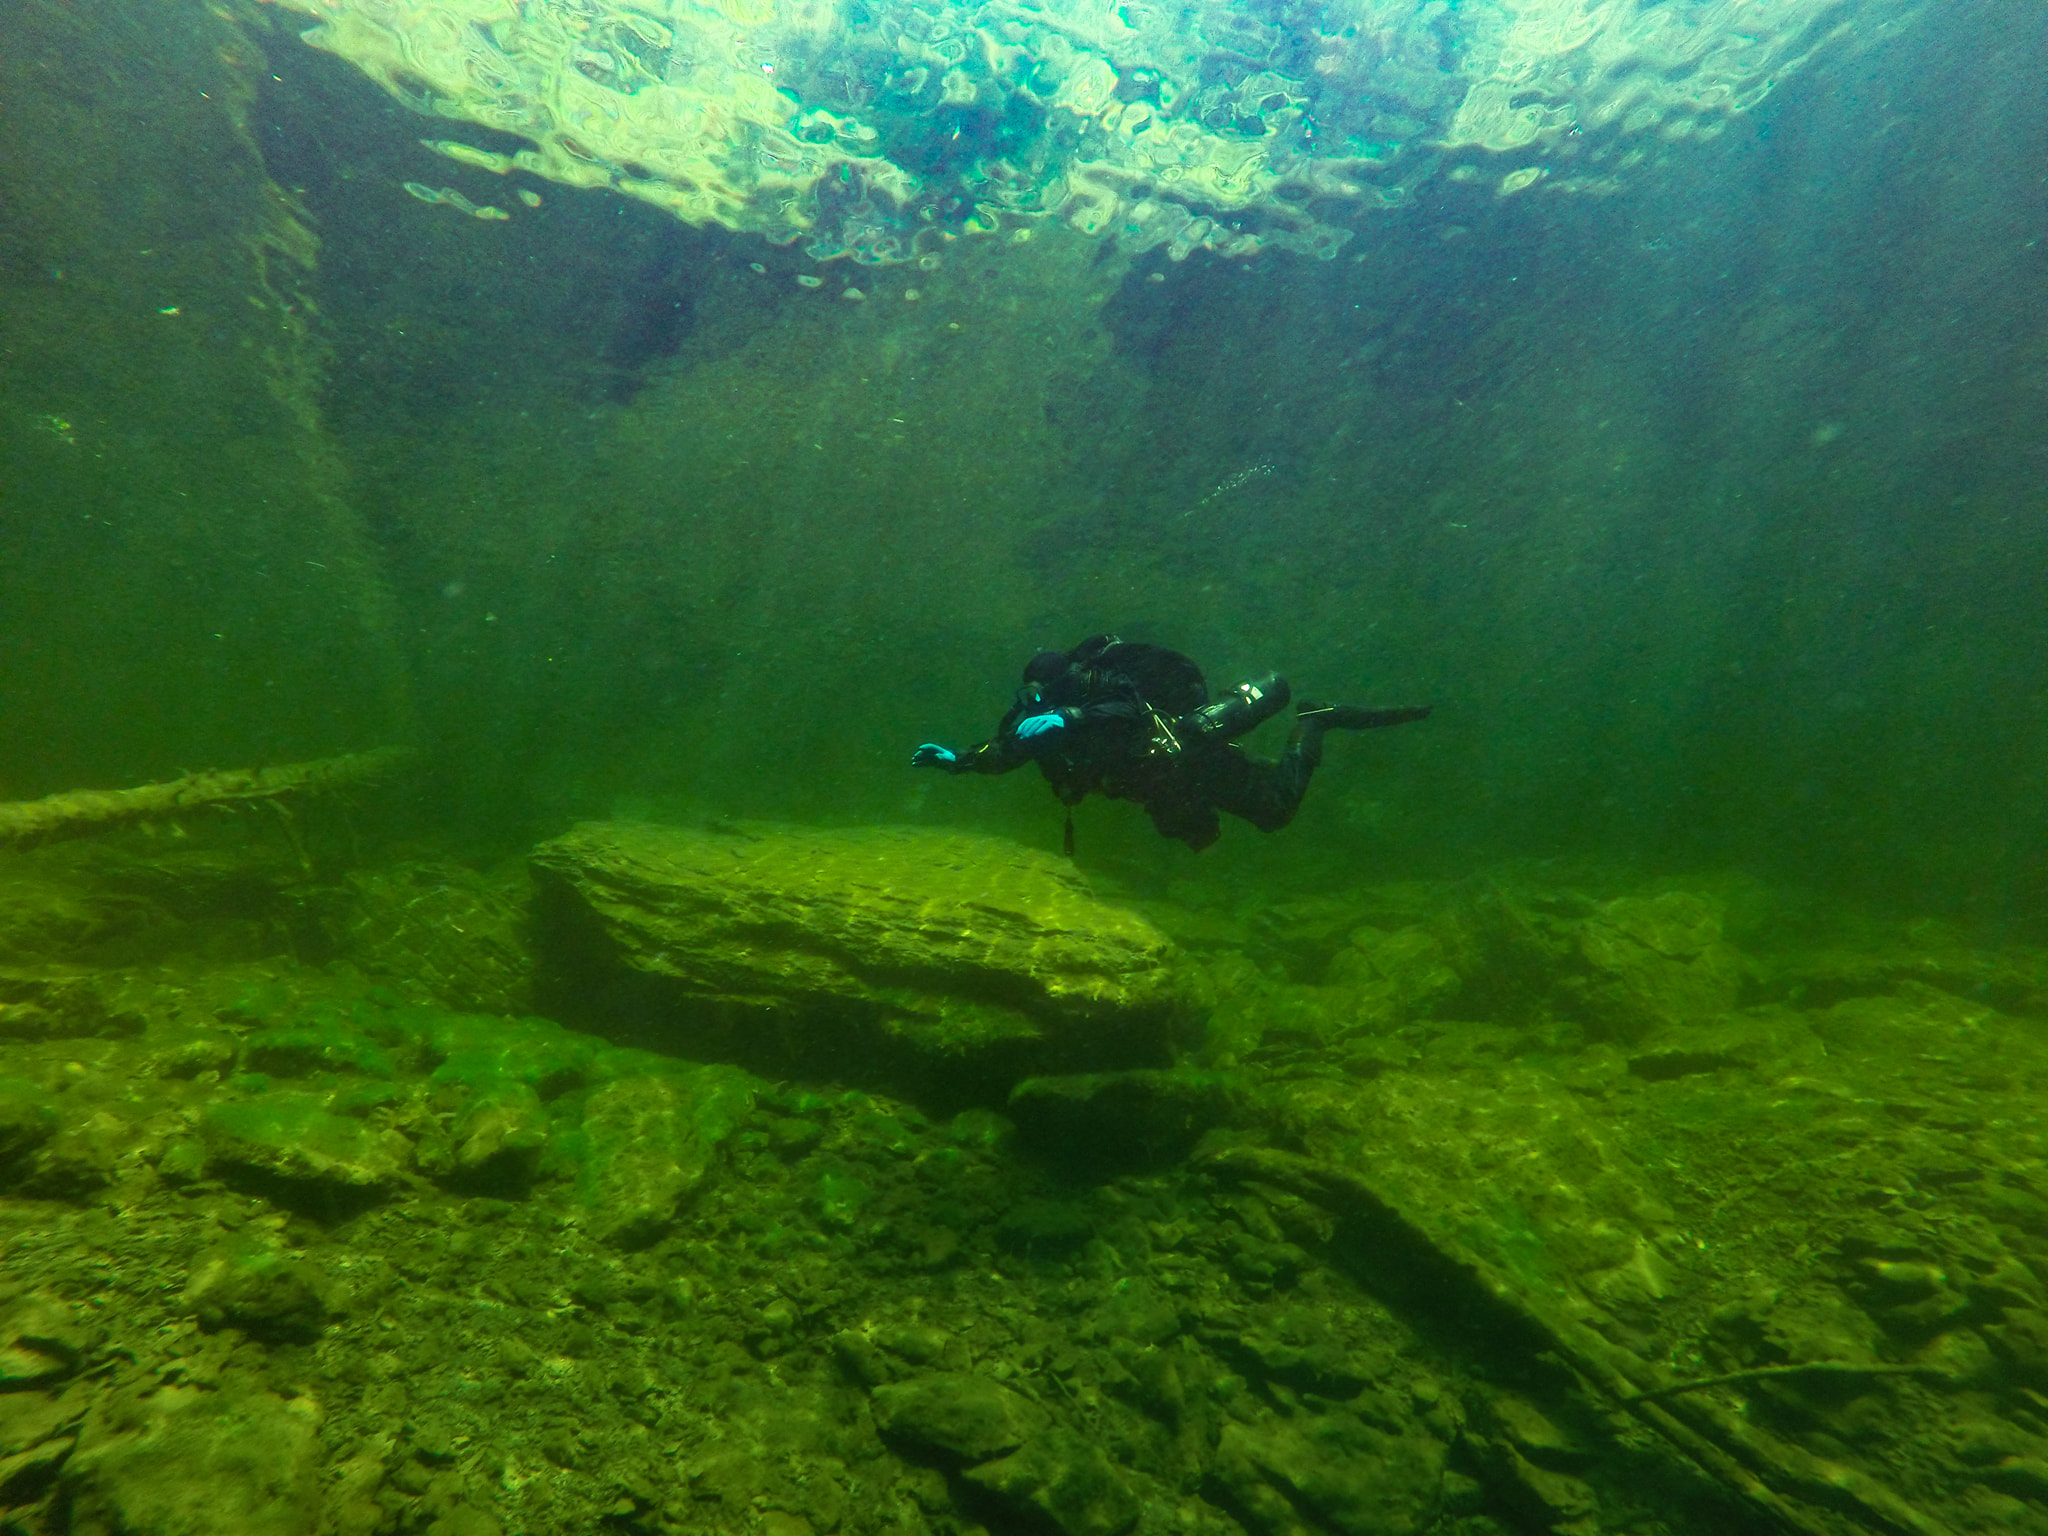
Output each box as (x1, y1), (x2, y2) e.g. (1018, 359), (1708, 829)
(532, 821), (1180, 1071)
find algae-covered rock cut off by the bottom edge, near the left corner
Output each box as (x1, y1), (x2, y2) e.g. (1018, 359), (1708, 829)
(61, 1386), (319, 1536)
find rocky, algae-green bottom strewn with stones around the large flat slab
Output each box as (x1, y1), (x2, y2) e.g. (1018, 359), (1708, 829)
(0, 831), (2048, 1536)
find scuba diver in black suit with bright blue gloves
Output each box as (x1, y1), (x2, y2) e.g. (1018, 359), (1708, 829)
(911, 635), (1430, 856)
